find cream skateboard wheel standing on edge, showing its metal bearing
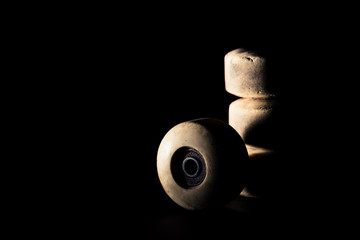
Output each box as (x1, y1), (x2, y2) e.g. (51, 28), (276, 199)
(157, 118), (249, 210)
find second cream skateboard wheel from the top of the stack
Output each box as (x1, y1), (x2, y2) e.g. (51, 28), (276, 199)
(229, 98), (281, 149)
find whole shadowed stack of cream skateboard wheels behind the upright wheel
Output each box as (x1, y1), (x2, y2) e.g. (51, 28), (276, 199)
(224, 48), (281, 197)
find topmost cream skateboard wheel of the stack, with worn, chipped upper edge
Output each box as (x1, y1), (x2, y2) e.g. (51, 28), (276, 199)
(224, 48), (276, 98)
